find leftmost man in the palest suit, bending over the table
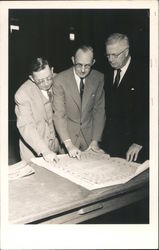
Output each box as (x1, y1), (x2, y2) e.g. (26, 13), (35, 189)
(15, 58), (59, 162)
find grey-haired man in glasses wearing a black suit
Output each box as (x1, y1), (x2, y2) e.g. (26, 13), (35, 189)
(103, 33), (148, 161)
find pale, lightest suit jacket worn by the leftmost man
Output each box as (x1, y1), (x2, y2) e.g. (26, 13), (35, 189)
(15, 80), (58, 161)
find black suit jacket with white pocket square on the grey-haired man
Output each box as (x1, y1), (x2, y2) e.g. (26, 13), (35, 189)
(103, 61), (148, 161)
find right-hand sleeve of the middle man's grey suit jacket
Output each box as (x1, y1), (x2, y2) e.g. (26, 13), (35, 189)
(92, 75), (106, 141)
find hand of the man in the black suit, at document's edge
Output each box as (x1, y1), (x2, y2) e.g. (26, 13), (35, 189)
(126, 143), (142, 162)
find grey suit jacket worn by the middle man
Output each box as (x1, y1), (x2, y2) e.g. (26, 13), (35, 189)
(53, 68), (105, 145)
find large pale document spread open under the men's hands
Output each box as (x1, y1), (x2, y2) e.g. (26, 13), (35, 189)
(31, 151), (149, 190)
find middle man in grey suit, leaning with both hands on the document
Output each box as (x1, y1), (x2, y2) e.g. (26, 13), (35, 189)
(53, 45), (105, 158)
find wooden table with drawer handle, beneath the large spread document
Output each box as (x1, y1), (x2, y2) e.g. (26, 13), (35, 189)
(9, 163), (149, 224)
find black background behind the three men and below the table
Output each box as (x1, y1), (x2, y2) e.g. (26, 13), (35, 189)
(8, 6), (149, 223)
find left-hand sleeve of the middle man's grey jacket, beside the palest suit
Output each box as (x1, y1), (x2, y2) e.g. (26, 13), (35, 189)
(53, 78), (70, 142)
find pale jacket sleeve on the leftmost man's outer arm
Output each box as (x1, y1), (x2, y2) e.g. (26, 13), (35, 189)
(15, 90), (50, 155)
